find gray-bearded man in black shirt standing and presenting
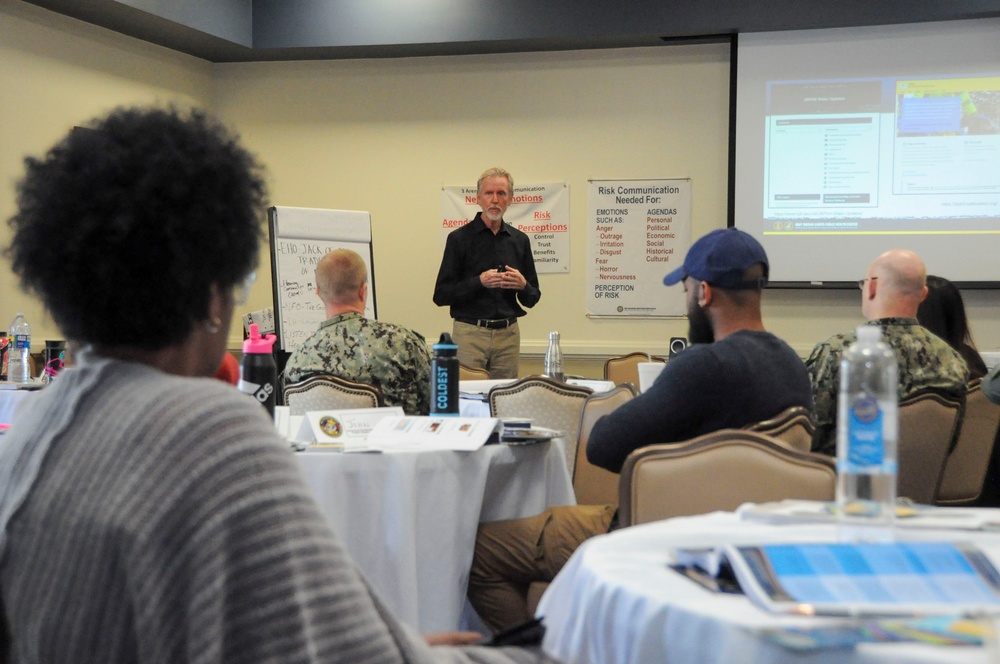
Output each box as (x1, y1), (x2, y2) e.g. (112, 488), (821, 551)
(434, 168), (542, 378)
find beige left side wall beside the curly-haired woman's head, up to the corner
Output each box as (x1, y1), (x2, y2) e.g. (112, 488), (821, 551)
(0, 0), (212, 340)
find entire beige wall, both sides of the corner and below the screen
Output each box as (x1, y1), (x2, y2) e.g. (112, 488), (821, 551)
(0, 0), (1000, 366)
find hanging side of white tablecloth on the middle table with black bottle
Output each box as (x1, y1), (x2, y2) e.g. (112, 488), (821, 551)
(297, 443), (575, 633)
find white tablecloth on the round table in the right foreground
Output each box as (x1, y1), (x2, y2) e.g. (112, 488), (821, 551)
(538, 512), (1000, 664)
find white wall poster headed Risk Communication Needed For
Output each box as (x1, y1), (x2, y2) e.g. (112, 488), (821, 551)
(586, 178), (691, 316)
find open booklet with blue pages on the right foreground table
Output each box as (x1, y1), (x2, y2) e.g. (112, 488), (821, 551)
(722, 541), (1000, 616)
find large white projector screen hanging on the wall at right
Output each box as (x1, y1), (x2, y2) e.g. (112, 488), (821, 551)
(732, 19), (1000, 288)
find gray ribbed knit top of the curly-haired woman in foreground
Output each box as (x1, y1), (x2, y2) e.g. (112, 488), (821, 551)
(0, 355), (552, 664)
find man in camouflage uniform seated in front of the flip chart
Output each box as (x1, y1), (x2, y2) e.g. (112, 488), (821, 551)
(283, 249), (431, 415)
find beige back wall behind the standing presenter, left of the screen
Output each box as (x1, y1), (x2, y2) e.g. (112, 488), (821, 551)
(215, 45), (728, 354)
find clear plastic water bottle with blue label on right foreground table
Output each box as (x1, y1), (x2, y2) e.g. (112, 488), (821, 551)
(837, 325), (899, 541)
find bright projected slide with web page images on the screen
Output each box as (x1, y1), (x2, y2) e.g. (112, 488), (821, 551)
(763, 76), (1000, 233)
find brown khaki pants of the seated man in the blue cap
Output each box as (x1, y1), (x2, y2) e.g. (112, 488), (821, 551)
(469, 505), (615, 632)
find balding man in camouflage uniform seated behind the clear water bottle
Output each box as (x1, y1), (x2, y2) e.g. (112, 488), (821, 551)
(806, 249), (969, 456)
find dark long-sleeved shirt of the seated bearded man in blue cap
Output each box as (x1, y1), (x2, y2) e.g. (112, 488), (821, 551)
(587, 330), (812, 473)
